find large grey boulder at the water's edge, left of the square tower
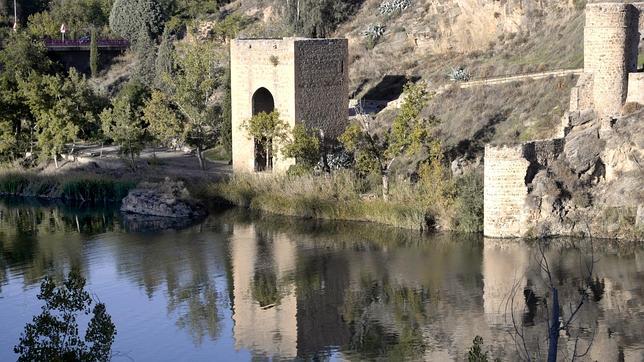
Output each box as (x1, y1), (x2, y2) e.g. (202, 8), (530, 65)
(121, 179), (207, 219)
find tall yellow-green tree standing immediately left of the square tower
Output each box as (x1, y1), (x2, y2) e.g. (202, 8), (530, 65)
(165, 43), (223, 169)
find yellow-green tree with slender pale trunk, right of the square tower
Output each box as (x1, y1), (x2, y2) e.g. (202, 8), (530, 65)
(340, 82), (439, 200)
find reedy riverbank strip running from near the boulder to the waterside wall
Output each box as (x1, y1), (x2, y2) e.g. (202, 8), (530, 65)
(195, 171), (483, 232)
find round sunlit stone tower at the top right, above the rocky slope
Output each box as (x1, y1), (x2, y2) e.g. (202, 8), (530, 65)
(584, 3), (639, 116)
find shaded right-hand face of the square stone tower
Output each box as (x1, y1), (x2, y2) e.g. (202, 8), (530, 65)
(295, 39), (349, 137)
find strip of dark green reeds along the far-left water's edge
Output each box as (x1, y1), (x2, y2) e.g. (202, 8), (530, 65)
(0, 171), (136, 202)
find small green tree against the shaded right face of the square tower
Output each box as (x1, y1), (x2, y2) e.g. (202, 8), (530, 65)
(282, 123), (320, 171)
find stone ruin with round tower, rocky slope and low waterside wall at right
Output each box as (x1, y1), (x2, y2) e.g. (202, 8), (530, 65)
(484, 2), (644, 237)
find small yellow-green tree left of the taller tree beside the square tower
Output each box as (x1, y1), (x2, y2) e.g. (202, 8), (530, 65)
(143, 91), (184, 146)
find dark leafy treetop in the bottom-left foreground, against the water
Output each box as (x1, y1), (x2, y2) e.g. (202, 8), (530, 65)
(14, 269), (116, 361)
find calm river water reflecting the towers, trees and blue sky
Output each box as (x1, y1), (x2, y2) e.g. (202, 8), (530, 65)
(0, 200), (644, 361)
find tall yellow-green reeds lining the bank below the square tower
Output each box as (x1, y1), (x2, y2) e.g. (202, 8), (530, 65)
(201, 171), (470, 230)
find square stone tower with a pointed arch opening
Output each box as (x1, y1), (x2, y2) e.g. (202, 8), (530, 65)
(230, 38), (349, 172)
